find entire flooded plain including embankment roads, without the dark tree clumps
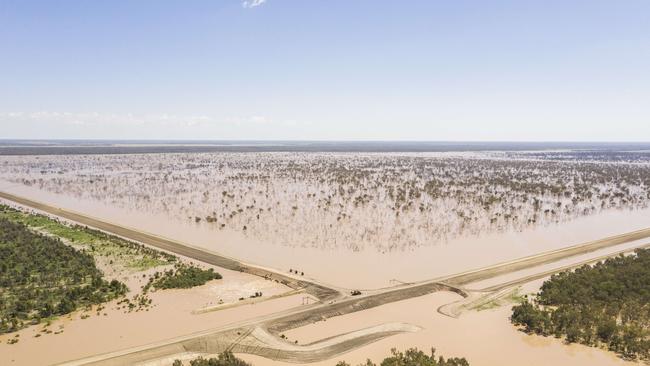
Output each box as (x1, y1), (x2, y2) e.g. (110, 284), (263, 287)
(0, 144), (650, 365)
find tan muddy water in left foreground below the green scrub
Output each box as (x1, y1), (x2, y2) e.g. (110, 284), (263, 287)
(0, 278), (302, 366)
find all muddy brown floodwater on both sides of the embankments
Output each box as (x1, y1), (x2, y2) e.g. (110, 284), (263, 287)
(0, 153), (650, 366)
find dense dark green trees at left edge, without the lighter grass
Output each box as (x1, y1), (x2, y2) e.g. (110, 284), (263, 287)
(0, 217), (127, 333)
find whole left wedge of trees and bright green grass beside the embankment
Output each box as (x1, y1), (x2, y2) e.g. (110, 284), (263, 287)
(0, 205), (221, 336)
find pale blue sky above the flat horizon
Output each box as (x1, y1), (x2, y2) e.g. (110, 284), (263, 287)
(0, 0), (650, 141)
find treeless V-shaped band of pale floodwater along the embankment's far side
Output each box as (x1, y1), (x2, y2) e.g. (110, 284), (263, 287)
(0, 182), (650, 289)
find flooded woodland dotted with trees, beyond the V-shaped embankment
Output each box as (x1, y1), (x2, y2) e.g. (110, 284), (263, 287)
(0, 150), (650, 288)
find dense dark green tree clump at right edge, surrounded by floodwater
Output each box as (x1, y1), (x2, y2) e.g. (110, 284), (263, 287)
(511, 249), (650, 360)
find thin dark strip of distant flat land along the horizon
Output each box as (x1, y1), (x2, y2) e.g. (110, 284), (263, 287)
(0, 139), (650, 155)
